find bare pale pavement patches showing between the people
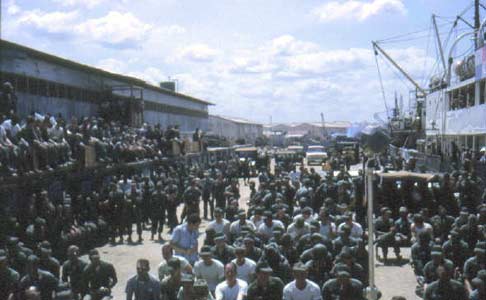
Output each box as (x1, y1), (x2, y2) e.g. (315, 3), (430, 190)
(89, 173), (419, 300)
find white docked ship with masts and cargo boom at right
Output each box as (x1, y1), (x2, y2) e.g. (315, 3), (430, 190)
(372, 0), (486, 171)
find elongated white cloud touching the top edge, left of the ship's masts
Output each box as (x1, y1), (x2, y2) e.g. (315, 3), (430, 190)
(313, 0), (407, 22)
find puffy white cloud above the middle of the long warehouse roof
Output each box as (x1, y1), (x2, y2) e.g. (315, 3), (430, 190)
(74, 11), (152, 45)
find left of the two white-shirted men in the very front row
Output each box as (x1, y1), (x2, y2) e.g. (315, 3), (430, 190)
(214, 263), (248, 300)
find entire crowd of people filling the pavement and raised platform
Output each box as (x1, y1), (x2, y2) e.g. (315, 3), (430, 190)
(0, 82), (486, 300)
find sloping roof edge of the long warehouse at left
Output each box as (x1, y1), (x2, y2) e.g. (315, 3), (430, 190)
(0, 39), (214, 105)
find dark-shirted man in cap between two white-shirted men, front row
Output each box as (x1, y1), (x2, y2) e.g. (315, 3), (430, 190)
(246, 262), (284, 300)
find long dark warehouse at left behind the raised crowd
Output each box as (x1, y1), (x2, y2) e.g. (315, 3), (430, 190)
(0, 40), (212, 132)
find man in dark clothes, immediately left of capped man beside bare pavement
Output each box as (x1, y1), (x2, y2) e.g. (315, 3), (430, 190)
(62, 245), (88, 299)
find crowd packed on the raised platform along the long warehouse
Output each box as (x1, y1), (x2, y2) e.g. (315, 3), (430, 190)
(0, 82), (192, 177)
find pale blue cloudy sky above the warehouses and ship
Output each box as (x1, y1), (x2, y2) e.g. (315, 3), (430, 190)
(0, 0), (478, 123)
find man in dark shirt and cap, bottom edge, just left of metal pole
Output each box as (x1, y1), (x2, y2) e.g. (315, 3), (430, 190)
(322, 269), (365, 300)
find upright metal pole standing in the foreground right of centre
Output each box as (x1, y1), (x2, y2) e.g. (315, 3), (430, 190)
(365, 158), (378, 300)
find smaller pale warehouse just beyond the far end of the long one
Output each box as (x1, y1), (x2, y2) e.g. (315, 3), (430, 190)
(209, 115), (263, 144)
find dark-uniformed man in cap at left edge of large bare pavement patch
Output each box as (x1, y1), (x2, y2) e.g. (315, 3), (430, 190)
(82, 250), (118, 300)
